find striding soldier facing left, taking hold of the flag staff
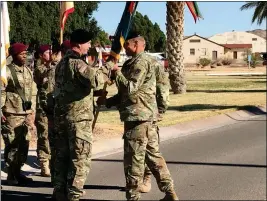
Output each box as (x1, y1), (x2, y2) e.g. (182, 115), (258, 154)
(101, 35), (178, 200)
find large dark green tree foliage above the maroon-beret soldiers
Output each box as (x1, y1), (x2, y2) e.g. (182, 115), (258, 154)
(8, 1), (110, 50)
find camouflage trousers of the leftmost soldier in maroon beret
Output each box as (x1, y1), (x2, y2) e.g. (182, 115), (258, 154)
(1, 113), (31, 170)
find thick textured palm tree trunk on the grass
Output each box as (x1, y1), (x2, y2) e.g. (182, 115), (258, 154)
(167, 1), (186, 94)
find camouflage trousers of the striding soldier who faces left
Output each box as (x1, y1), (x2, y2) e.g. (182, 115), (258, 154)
(123, 122), (173, 200)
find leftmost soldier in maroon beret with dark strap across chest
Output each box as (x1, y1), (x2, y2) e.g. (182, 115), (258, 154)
(1, 43), (33, 185)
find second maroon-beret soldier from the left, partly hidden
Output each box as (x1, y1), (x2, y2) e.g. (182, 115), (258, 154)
(33, 45), (55, 177)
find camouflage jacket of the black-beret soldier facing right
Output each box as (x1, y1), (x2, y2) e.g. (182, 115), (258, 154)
(54, 51), (111, 122)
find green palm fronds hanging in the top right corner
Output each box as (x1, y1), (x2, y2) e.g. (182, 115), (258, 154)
(240, 1), (267, 25)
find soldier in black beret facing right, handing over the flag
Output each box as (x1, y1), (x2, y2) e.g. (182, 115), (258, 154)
(53, 29), (115, 201)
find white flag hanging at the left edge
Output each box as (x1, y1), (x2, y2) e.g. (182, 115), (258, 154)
(1, 2), (10, 86)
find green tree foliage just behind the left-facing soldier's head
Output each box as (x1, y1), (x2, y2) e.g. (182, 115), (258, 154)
(130, 12), (166, 52)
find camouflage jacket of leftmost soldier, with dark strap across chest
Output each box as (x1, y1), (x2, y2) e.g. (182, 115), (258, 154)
(1, 63), (33, 114)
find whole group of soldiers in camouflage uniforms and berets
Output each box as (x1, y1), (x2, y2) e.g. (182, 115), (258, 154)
(1, 29), (178, 201)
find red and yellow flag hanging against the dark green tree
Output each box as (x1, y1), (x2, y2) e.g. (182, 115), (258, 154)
(60, 1), (74, 30)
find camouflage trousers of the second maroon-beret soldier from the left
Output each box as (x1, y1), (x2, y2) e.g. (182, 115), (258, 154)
(35, 109), (51, 161)
